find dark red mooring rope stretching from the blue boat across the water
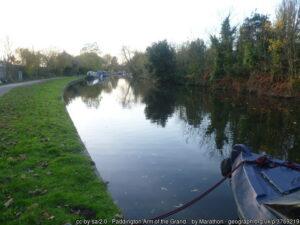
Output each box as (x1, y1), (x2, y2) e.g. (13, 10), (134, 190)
(139, 161), (244, 220)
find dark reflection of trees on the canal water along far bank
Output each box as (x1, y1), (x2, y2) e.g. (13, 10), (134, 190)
(64, 77), (300, 162)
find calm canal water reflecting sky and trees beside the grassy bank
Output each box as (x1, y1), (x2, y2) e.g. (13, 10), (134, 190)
(65, 78), (300, 219)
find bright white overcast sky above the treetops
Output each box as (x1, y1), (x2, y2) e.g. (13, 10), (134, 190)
(0, 0), (281, 56)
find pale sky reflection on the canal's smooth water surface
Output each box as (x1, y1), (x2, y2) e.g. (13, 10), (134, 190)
(67, 80), (236, 218)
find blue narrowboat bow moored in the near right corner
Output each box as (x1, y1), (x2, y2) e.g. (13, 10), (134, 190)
(222, 144), (300, 221)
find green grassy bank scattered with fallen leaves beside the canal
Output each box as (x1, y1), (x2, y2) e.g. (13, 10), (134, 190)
(0, 78), (118, 225)
